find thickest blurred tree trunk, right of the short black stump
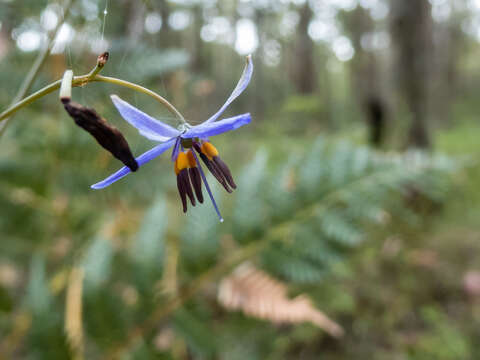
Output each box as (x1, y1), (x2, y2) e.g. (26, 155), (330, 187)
(391, 0), (433, 148)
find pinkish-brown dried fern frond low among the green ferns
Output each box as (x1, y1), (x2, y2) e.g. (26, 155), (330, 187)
(218, 263), (343, 337)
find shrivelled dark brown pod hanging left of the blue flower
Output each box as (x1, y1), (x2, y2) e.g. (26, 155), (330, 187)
(62, 98), (138, 171)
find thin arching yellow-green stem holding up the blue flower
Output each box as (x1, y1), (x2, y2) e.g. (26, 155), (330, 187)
(0, 74), (186, 124)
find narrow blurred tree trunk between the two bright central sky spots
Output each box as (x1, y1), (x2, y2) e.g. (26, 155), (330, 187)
(293, 2), (317, 94)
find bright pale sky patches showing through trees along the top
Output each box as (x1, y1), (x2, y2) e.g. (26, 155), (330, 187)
(12, 0), (480, 66)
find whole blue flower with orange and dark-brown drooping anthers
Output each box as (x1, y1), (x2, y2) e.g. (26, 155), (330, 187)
(92, 56), (253, 221)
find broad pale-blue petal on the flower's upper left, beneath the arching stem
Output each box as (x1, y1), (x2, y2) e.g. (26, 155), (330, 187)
(111, 95), (180, 141)
